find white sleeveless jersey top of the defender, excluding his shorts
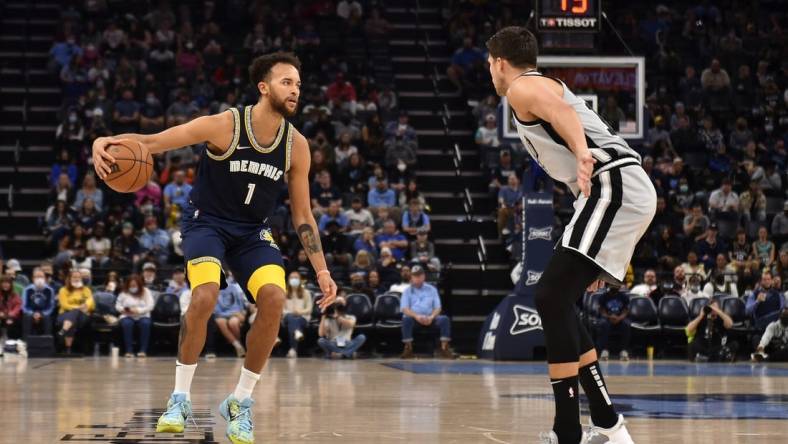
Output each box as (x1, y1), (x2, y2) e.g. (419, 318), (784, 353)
(514, 71), (640, 196)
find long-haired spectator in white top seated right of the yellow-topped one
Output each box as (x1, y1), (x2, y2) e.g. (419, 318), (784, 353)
(115, 274), (154, 358)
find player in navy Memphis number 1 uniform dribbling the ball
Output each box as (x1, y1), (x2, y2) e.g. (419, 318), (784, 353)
(93, 52), (336, 444)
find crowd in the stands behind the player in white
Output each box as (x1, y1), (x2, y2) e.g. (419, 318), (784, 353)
(444, 1), (788, 359)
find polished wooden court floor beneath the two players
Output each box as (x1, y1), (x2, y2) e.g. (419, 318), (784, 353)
(0, 355), (788, 444)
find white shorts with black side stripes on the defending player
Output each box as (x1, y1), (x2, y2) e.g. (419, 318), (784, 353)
(561, 165), (657, 284)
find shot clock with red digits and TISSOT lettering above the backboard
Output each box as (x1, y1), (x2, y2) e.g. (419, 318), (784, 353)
(535, 0), (602, 32)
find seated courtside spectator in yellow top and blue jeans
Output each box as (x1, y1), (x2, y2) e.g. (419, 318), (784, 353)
(57, 270), (96, 354)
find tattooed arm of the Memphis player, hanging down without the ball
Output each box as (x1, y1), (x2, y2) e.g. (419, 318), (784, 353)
(287, 133), (337, 310)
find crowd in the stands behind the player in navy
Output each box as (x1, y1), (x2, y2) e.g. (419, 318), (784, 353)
(0, 0), (450, 356)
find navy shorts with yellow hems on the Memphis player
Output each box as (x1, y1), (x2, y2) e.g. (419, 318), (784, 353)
(181, 205), (287, 303)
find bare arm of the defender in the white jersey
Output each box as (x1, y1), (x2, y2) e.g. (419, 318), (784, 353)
(506, 78), (596, 196)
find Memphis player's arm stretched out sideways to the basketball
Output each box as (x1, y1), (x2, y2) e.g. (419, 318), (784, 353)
(93, 111), (234, 179)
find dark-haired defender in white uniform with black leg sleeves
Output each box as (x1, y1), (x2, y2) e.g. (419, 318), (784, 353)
(487, 26), (657, 444)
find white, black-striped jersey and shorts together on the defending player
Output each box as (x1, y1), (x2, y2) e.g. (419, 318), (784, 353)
(514, 71), (657, 285)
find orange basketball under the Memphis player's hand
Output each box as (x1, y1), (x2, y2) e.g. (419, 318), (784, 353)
(104, 139), (153, 193)
